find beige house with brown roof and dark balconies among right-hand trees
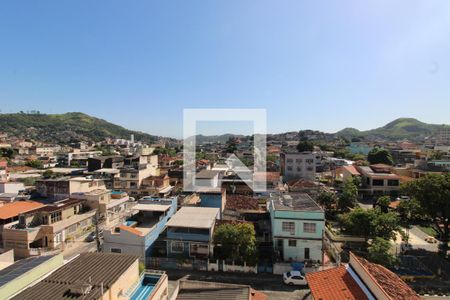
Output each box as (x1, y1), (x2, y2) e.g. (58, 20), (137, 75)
(357, 164), (400, 196)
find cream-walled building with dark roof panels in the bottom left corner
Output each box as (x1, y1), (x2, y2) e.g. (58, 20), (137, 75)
(0, 250), (63, 299)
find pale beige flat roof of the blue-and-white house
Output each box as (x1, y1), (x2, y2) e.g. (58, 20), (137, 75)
(166, 206), (220, 229)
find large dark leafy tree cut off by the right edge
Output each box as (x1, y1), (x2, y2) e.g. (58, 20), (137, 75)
(402, 173), (450, 255)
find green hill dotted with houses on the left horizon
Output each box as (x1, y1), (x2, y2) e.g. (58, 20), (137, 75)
(0, 112), (158, 144)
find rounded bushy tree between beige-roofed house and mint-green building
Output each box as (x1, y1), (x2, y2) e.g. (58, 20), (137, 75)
(213, 223), (257, 264)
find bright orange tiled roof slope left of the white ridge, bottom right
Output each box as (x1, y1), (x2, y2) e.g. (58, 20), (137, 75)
(306, 266), (368, 300)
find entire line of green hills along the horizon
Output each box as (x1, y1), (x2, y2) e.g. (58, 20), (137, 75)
(0, 112), (450, 144)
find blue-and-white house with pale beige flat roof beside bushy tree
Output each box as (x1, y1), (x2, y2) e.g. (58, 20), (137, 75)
(166, 207), (220, 259)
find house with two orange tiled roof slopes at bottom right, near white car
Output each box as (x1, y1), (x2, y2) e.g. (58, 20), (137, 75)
(306, 253), (421, 300)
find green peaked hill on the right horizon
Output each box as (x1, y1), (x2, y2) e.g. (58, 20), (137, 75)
(336, 118), (450, 140)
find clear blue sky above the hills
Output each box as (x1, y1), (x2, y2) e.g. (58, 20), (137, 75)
(0, 0), (450, 137)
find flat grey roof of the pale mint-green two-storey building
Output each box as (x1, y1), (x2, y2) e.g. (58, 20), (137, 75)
(270, 193), (323, 212)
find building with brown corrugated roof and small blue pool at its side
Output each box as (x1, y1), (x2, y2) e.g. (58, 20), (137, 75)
(12, 253), (168, 300)
